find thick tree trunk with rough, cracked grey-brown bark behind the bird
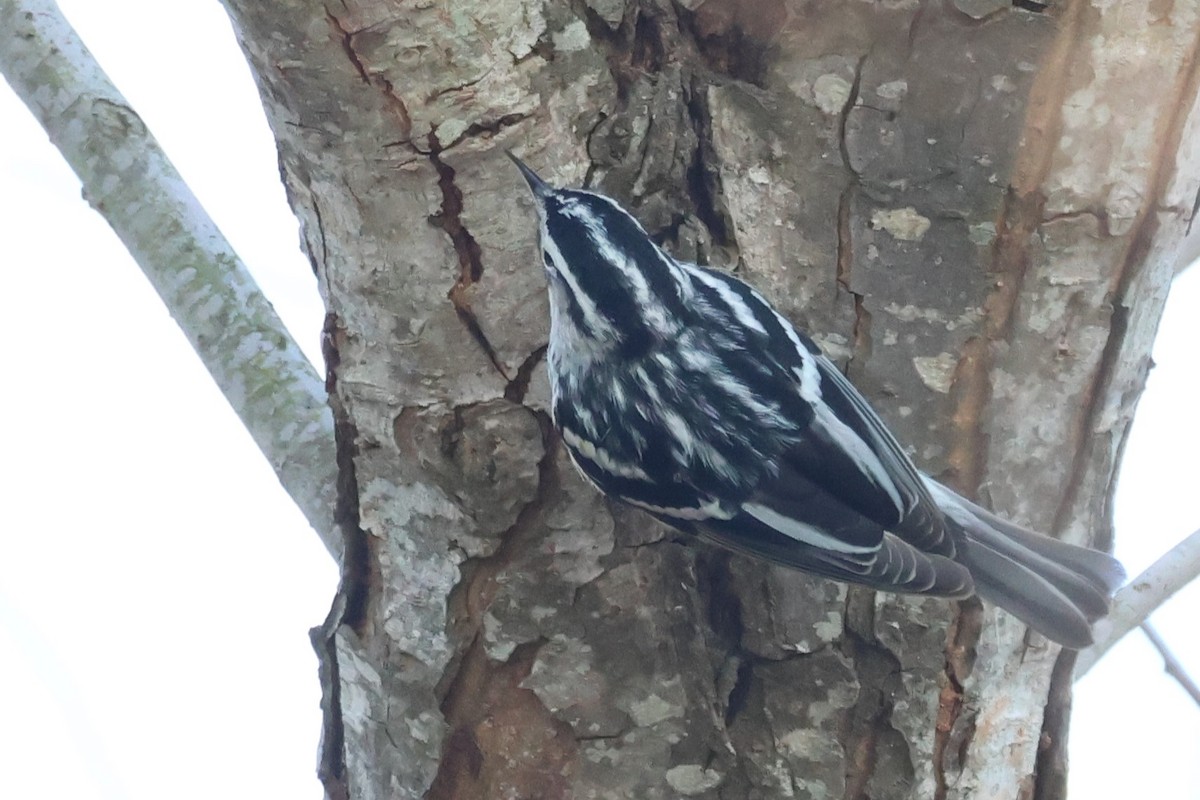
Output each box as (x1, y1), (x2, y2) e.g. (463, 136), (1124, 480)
(226, 0), (1200, 800)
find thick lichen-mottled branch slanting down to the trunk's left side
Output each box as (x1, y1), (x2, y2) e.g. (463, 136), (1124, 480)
(0, 0), (341, 557)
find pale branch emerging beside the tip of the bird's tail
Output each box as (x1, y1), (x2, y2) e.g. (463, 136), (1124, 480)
(1075, 530), (1200, 680)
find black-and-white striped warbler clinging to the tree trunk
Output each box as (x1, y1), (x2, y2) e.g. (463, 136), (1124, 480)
(510, 154), (1124, 648)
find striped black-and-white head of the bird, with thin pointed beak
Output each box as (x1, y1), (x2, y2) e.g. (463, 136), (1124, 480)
(508, 152), (690, 353)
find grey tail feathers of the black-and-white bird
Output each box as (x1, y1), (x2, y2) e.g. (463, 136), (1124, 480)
(926, 479), (1126, 649)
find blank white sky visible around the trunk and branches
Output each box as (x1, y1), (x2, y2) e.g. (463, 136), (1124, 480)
(0, 0), (1200, 800)
